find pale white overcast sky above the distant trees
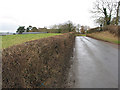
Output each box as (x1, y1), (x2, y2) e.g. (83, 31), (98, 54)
(0, 0), (95, 32)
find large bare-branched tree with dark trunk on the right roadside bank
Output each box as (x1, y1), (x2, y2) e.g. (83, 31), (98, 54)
(92, 0), (117, 25)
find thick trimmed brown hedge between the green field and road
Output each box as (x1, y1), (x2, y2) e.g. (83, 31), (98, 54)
(2, 33), (74, 88)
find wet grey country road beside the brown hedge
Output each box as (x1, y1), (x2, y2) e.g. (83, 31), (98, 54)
(68, 36), (118, 88)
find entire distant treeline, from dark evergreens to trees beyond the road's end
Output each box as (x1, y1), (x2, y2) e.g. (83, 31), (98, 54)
(16, 21), (90, 34)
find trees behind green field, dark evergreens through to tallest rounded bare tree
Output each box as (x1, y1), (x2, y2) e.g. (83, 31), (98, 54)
(16, 21), (76, 34)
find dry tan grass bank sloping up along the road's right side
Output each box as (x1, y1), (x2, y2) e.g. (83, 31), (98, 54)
(87, 31), (120, 44)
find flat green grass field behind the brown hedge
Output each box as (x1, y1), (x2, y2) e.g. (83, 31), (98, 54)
(0, 33), (61, 49)
